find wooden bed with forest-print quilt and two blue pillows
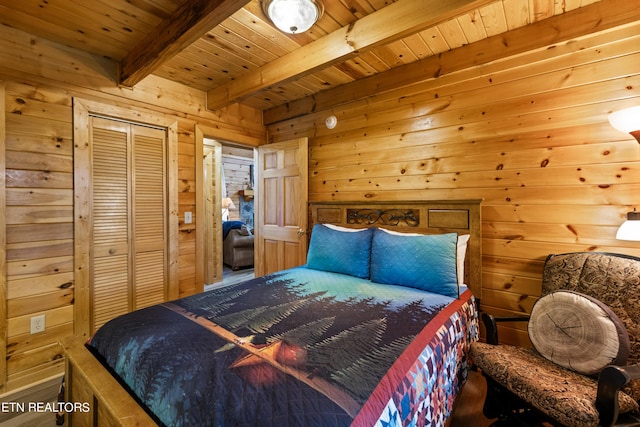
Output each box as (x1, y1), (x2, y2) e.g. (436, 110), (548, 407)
(64, 200), (481, 427)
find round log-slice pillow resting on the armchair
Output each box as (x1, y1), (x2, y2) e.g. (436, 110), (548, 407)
(528, 291), (630, 375)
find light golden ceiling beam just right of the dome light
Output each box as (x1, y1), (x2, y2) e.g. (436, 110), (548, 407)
(207, 0), (493, 110)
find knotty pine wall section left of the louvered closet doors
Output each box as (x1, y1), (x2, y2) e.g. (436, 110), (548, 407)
(2, 83), (74, 389)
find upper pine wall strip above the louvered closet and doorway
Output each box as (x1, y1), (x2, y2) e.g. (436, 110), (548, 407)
(0, 26), (266, 146)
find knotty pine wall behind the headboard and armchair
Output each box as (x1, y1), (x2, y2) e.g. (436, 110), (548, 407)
(269, 17), (640, 345)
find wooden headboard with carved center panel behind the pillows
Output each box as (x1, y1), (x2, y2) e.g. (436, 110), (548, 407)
(309, 200), (482, 299)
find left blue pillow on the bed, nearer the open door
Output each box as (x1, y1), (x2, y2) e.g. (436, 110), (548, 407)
(307, 224), (373, 279)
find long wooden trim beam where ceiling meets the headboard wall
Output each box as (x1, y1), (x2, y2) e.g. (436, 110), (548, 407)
(263, 0), (640, 125)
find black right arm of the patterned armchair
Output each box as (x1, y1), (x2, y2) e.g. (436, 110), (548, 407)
(596, 365), (640, 426)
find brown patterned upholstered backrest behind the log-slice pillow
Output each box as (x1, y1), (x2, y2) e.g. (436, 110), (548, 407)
(542, 252), (640, 401)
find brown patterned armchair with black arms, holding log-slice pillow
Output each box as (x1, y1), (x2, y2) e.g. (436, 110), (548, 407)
(470, 252), (640, 427)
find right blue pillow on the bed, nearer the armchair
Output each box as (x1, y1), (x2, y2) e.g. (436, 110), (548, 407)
(371, 229), (459, 298)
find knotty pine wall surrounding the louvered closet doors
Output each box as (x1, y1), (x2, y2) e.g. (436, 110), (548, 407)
(0, 26), (266, 395)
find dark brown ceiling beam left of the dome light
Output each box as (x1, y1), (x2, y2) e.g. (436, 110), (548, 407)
(119, 0), (249, 87)
